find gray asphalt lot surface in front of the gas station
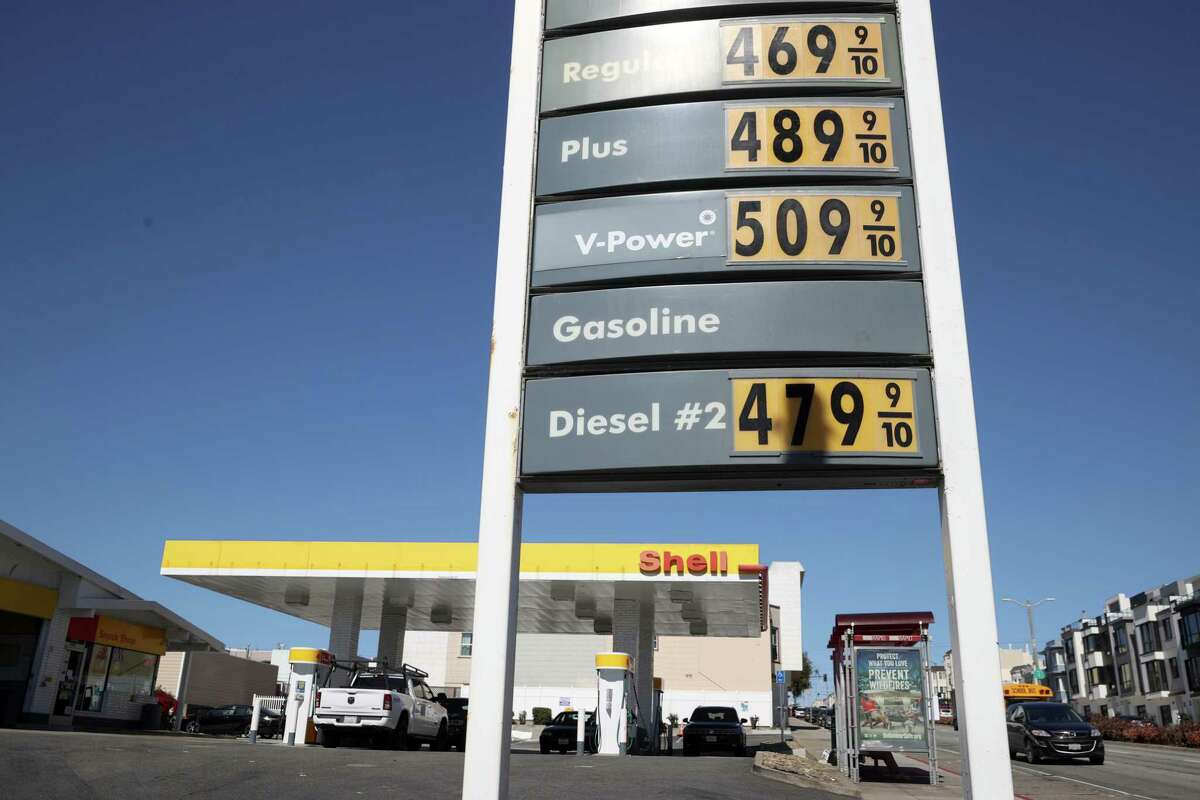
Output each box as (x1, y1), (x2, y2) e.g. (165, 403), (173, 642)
(0, 730), (835, 800)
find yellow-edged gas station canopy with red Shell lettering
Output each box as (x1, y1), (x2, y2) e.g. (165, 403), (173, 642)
(161, 541), (768, 637)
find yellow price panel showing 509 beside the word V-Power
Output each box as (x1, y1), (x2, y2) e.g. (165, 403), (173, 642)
(725, 190), (905, 265)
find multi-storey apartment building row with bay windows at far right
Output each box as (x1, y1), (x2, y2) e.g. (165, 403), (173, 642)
(1044, 568), (1200, 724)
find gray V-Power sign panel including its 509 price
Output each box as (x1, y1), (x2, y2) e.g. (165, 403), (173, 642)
(533, 186), (920, 287)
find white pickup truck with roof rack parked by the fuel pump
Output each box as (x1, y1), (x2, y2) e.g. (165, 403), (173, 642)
(312, 664), (450, 750)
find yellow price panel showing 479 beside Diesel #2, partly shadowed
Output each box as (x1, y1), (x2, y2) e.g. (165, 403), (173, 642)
(731, 378), (920, 455)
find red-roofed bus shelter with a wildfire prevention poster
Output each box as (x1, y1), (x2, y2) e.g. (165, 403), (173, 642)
(828, 612), (937, 784)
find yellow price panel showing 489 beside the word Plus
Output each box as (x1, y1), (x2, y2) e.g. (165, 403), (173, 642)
(725, 101), (895, 172)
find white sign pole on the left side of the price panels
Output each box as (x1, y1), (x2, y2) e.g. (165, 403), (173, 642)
(462, 0), (542, 800)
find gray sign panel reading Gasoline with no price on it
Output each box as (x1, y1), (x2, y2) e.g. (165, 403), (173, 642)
(527, 281), (929, 366)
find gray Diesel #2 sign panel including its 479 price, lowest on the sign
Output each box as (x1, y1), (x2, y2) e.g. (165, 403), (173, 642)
(521, 368), (938, 487)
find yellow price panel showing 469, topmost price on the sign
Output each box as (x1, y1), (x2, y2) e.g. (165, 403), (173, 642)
(721, 17), (888, 84)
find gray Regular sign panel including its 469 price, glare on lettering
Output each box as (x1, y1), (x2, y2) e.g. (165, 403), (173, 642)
(541, 14), (900, 112)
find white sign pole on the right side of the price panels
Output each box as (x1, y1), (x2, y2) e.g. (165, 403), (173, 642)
(898, 0), (1013, 799)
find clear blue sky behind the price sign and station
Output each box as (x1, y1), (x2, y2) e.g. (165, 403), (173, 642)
(0, 0), (1200, 671)
